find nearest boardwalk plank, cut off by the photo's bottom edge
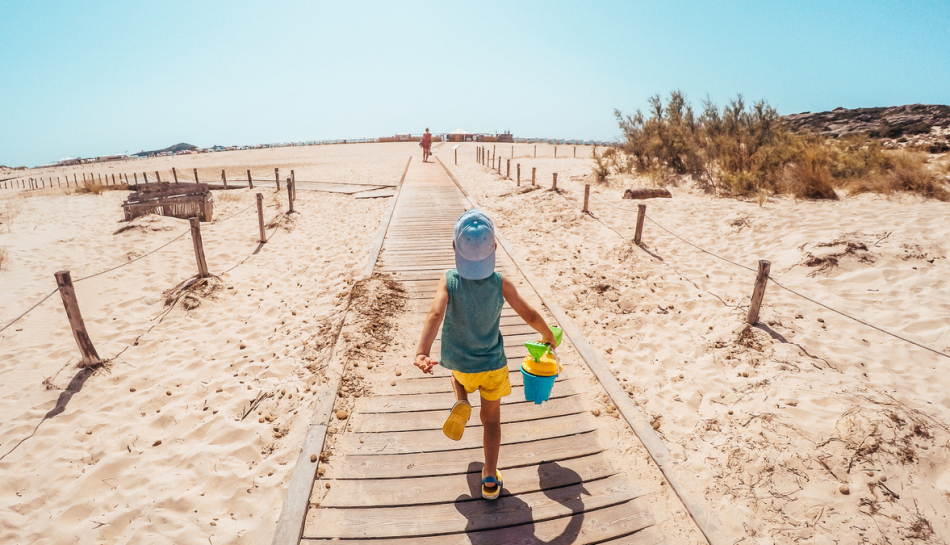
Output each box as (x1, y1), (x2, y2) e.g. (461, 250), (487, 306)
(301, 499), (665, 545)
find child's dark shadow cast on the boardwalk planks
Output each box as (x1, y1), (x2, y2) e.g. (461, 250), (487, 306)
(455, 462), (589, 545)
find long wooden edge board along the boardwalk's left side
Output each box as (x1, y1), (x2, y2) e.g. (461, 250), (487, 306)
(272, 156), (412, 545)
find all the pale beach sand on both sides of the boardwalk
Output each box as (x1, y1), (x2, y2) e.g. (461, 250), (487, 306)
(0, 143), (950, 544)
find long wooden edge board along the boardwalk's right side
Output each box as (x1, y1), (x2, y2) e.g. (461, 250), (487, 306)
(436, 157), (726, 545)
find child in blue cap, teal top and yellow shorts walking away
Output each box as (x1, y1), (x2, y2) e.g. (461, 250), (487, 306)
(415, 208), (557, 500)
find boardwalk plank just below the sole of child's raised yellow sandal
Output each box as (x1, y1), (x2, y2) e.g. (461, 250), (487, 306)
(337, 413), (595, 454)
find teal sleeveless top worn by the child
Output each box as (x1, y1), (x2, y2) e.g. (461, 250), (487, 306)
(439, 269), (508, 373)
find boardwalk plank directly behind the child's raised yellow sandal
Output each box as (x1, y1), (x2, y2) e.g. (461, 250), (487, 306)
(347, 392), (584, 434)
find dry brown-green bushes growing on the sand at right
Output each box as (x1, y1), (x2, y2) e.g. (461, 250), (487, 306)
(608, 91), (950, 202)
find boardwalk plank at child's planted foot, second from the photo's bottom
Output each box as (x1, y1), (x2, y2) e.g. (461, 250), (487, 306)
(304, 476), (652, 539)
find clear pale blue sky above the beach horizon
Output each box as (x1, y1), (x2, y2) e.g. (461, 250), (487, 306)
(0, 0), (950, 166)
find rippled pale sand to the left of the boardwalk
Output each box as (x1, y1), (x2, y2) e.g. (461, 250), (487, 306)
(0, 144), (411, 544)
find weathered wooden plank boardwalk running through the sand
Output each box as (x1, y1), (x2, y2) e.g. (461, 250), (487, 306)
(300, 161), (663, 545)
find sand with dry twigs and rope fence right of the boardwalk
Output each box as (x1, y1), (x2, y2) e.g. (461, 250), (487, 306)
(450, 142), (950, 543)
